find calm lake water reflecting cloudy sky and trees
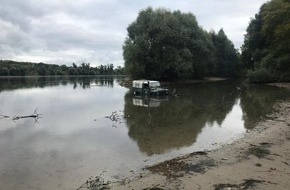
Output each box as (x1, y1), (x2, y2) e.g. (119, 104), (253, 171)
(0, 77), (289, 190)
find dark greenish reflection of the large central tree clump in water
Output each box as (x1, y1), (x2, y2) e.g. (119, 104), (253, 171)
(125, 82), (238, 155)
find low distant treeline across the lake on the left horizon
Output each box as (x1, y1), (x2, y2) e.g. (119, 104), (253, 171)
(0, 60), (123, 76)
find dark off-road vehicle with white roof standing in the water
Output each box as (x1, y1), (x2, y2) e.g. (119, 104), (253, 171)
(132, 80), (169, 96)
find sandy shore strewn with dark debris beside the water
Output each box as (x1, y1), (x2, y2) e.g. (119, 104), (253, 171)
(109, 102), (290, 190)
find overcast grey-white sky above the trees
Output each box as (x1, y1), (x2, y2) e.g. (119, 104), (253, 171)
(0, 0), (267, 66)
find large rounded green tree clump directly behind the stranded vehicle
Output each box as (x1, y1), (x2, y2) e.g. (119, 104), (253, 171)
(123, 7), (239, 79)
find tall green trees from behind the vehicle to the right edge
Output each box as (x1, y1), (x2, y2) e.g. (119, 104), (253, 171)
(123, 0), (290, 82)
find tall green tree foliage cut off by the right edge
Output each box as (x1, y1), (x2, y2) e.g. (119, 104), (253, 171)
(242, 0), (290, 82)
